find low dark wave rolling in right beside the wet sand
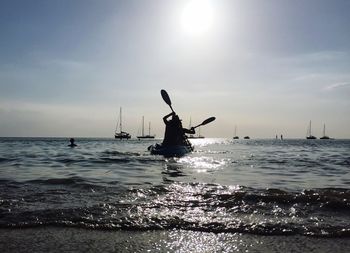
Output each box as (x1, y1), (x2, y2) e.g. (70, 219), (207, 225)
(0, 210), (350, 238)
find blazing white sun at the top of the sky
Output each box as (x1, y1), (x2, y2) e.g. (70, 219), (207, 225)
(181, 0), (213, 35)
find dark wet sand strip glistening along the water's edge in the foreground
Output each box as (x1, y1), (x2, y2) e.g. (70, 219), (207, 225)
(0, 227), (350, 253)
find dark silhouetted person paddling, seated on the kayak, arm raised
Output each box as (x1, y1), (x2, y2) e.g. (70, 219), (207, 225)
(163, 112), (196, 146)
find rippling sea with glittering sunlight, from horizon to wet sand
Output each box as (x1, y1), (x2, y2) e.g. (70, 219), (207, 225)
(0, 138), (350, 237)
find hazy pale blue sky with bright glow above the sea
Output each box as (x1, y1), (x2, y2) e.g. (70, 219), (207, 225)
(0, 0), (350, 138)
